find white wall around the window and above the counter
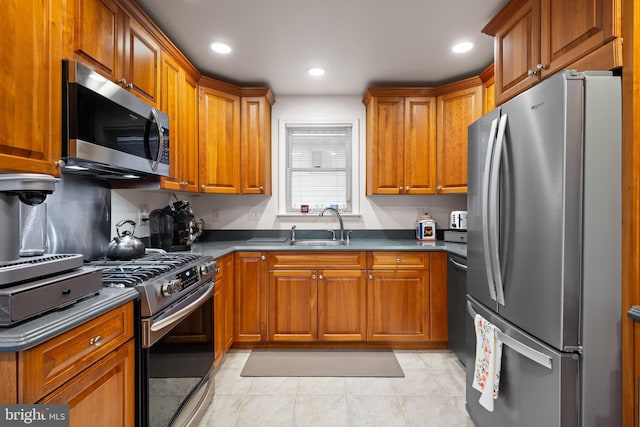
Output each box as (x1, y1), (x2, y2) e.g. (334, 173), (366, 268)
(111, 96), (467, 237)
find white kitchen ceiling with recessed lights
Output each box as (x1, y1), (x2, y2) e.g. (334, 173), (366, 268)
(137, 0), (507, 97)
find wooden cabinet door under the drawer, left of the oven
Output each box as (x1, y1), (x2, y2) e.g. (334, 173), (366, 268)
(38, 340), (136, 427)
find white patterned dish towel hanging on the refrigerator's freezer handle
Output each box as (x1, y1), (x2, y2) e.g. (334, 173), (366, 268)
(472, 314), (502, 412)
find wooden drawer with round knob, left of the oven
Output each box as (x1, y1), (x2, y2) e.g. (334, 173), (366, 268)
(18, 302), (133, 403)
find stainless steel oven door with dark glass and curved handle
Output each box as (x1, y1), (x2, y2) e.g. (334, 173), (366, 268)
(140, 282), (214, 427)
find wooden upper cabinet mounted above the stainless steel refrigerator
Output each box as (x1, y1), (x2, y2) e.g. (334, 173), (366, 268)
(482, 0), (622, 104)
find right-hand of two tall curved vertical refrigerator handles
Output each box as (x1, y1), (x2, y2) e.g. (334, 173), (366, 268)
(485, 114), (507, 305)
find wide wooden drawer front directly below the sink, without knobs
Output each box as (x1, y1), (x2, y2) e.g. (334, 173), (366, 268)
(268, 251), (366, 270)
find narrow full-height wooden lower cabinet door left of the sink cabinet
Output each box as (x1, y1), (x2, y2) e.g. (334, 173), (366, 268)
(234, 252), (267, 342)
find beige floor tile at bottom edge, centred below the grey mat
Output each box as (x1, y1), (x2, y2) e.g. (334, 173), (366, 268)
(292, 394), (349, 427)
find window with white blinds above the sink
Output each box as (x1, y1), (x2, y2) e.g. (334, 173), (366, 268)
(281, 123), (357, 214)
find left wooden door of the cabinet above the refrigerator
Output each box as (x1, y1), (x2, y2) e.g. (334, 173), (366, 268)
(494, 0), (540, 104)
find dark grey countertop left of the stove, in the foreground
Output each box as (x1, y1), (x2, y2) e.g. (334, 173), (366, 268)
(0, 288), (139, 352)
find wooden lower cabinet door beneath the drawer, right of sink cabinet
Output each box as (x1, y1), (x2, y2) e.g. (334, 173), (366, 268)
(367, 270), (431, 341)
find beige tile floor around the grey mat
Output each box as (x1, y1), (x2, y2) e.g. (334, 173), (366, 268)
(199, 350), (473, 427)
